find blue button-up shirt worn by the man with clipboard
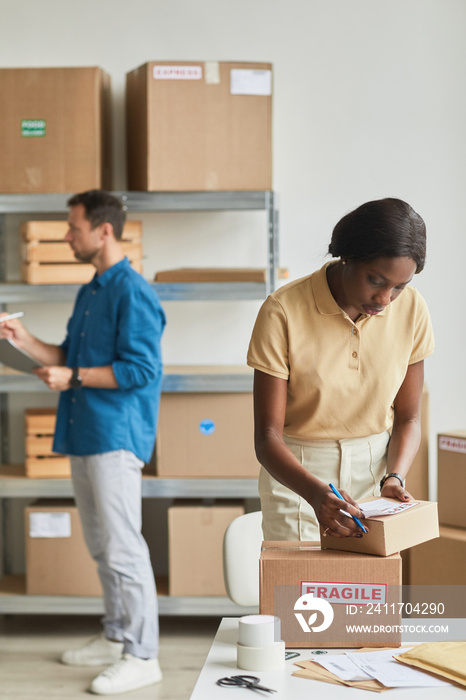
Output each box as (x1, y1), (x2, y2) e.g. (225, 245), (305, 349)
(53, 258), (165, 462)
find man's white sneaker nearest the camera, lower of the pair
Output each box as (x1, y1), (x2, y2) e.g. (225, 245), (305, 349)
(90, 654), (162, 695)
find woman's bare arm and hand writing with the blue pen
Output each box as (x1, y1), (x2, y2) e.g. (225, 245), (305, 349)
(254, 370), (364, 537)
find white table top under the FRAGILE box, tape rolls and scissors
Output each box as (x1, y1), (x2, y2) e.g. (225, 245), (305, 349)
(191, 618), (466, 700)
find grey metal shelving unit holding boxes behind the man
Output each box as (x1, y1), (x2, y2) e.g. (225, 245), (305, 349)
(0, 192), (278, 615)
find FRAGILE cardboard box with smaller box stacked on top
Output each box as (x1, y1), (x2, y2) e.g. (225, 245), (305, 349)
(260, 499), (438, 647)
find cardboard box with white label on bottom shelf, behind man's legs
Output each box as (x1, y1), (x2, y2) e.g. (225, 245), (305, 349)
(25, 501), (102, 596)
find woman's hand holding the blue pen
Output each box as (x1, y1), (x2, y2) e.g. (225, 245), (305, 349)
(310, 483), (365, 537)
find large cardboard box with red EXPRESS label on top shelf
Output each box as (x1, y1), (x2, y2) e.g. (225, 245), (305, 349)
(126, 61), (272, 192)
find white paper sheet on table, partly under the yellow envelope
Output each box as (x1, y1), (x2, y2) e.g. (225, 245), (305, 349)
(347, 649), (451, 688)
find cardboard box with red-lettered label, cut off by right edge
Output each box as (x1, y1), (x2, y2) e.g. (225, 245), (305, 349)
(437, 430), (466, 528)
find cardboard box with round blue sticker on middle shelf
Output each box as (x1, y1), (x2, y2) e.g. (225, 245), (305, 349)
(156, 392), (259, 478)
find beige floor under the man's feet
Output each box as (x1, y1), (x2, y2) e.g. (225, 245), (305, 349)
(0, 615), (220, 700)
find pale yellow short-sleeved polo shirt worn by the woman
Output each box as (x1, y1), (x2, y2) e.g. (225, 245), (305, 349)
(247, 261), (434, 440)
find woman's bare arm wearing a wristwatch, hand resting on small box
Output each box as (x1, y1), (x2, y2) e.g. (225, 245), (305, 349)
(382, 361), (424, 501)
